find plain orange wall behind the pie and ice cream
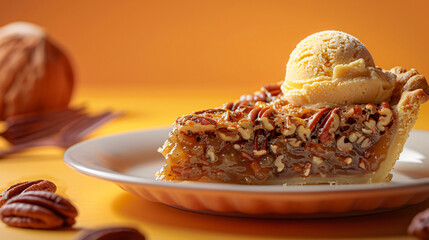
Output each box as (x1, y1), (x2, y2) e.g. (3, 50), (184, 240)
(0, 0), (429, 96)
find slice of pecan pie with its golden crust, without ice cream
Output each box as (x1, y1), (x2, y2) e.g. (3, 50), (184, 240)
(157, 31), (429, 184)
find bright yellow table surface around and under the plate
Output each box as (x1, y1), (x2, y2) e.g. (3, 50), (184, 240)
(0, 89), (429, 240)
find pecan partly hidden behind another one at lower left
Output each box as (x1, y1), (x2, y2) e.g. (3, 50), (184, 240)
(0, 180), (57, 207)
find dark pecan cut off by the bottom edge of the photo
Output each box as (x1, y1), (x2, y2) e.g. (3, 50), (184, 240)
(78, 227), (145, 240)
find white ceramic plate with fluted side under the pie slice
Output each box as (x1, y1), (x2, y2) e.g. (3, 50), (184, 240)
(64, 128), (429, 217)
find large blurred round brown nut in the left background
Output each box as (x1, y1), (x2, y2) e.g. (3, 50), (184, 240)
(0, 22), (74, 120)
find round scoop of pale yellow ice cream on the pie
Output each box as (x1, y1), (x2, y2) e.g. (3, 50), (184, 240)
(282, 31), (395, 106)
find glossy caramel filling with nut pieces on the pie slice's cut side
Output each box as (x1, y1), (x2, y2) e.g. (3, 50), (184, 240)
(158, 104), (395, 184)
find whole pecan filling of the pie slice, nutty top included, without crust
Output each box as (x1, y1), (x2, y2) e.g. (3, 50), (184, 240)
(157, 85), (397, 184)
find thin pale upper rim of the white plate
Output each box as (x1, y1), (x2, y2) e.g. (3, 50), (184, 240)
(63, 127), (429, 195)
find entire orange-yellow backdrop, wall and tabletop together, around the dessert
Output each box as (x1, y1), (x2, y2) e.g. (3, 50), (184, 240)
(0, 0), (429, 240)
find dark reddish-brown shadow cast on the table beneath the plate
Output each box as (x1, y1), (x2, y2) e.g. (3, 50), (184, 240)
(113, 193), (429, 238)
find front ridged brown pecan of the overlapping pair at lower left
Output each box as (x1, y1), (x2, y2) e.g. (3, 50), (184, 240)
(0, 191), (77, 229)
